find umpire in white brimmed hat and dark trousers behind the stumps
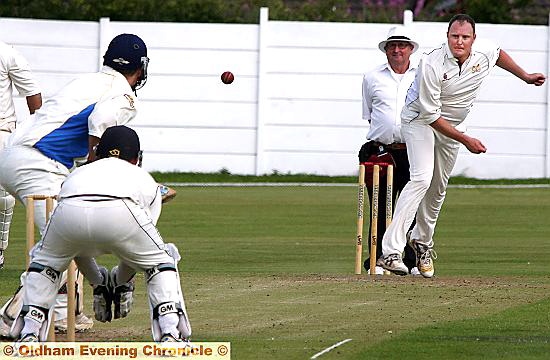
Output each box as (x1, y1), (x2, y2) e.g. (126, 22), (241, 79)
(359, 26), (418, 274)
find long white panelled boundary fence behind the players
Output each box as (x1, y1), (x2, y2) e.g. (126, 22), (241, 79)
(0, 9), (550, 178)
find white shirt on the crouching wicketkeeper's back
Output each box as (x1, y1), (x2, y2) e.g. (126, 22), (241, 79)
(58, 157), (162, 223)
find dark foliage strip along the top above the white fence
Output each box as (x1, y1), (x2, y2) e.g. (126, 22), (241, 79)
(0, 0), (550, 24)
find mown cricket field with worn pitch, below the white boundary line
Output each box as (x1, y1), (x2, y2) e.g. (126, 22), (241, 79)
(0, 187), (550, 359)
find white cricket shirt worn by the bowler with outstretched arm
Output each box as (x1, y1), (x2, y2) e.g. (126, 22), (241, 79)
(401, 40), (500, 126)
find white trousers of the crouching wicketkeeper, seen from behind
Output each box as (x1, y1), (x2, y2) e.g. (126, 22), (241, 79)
(31, 198), (174, 277)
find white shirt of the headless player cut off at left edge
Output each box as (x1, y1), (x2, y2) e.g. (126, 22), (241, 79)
(0, 41), (40, 127)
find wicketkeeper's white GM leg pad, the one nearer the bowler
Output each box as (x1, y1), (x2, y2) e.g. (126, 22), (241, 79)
(147, 264), (191, 341)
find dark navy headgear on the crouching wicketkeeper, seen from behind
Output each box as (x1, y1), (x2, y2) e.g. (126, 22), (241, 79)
(96, 125), (141, 161)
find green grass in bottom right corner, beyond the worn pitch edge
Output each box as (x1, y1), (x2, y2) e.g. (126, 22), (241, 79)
(358, 299), (550, 359)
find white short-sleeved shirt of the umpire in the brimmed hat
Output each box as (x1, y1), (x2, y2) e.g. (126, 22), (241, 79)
(363, 63), (416, 144)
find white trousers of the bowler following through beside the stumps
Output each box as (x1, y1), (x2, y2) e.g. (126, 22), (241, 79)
(382, 121), (460, 256)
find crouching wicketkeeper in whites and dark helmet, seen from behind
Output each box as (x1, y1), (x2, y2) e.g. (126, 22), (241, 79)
(11, 126), (191, 342)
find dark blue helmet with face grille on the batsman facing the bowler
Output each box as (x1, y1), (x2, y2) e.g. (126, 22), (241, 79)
(103, 34), (149, 90)
